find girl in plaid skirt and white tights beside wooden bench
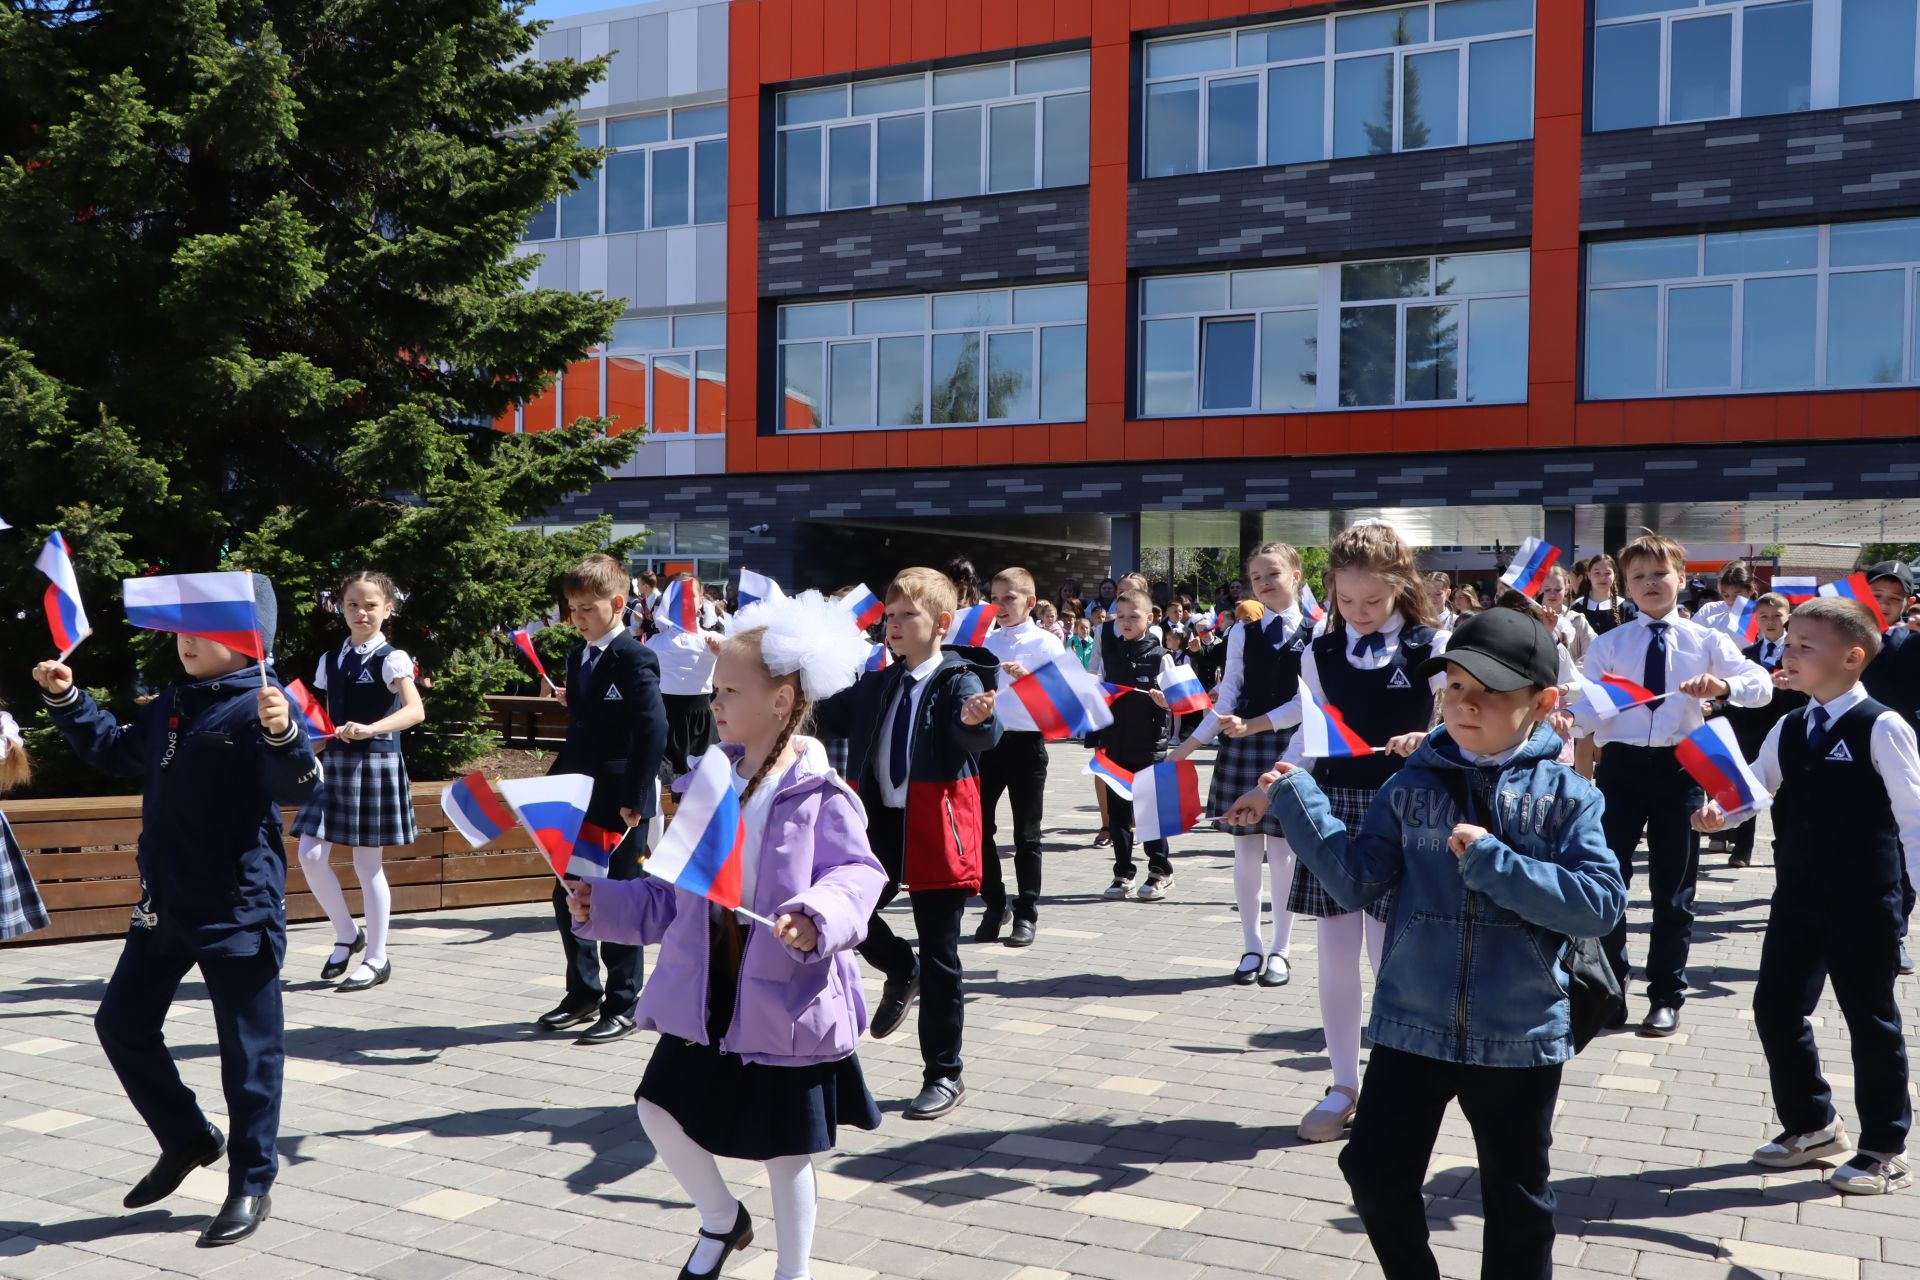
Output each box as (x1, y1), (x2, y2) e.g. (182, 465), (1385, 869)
(294, 572), (426, 990)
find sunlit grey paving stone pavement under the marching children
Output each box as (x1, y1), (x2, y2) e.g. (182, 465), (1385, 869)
(0, 747), (1920, 1280)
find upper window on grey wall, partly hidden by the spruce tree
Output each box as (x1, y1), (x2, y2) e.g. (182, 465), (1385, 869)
(520, 102), (726, 240)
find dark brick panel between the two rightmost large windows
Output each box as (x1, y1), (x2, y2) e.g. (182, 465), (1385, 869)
(1580, 102), (1920, 232)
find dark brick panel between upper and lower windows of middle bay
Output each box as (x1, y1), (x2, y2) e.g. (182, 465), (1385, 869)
(1127, 140), (1534, 271)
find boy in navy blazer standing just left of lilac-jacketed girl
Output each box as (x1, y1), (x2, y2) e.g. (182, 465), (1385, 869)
(540, 555), (666, 1044)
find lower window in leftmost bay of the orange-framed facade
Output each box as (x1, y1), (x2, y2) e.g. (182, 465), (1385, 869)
(780, 284), (1087, 430)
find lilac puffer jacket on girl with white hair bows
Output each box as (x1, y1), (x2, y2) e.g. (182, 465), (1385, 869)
(574, 737), (887, 1067)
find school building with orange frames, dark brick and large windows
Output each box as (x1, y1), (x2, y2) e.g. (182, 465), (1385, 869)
(497, 0), (1920, 587)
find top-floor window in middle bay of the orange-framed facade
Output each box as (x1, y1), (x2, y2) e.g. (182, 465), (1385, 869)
(1142, 0), (1534, 178)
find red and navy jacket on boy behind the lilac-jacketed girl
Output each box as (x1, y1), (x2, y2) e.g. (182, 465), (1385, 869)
(816, 645), (1000, 890)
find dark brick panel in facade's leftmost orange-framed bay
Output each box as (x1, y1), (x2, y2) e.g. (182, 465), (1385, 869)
(760, 186), (1087, 299)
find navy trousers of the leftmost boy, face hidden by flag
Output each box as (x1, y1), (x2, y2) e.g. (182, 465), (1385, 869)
(94, 917), (286, 1196)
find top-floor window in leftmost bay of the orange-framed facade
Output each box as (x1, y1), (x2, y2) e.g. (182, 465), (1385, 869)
(774, 54), (1087, 215)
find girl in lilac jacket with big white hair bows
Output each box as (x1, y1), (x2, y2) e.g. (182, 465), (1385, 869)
(572, 591), (887, 1280)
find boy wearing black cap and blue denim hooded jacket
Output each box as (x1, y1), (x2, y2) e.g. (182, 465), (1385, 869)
(1227, 608), (1626, 1280)
